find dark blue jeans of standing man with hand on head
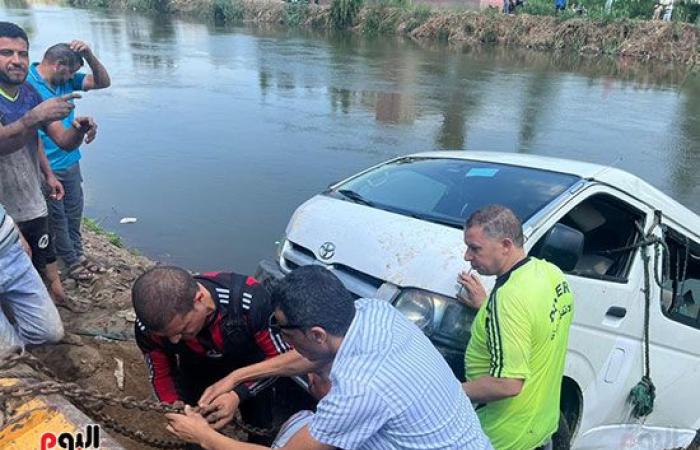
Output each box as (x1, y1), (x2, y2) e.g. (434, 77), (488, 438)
(47, 163), (83, 267)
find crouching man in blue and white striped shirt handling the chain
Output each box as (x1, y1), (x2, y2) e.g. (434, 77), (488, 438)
(167, 266), (491, 450)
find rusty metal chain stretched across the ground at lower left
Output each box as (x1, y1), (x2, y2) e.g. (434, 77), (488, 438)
(0, 347), (274, 449)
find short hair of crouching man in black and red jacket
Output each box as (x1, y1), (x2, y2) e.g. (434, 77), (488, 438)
(131, 266), (198, 332)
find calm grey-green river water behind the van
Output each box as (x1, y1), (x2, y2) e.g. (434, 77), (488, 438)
(0, 6), (700, 271)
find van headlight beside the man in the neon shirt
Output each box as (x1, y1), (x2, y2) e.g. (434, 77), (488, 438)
(394, 289), (475, 349)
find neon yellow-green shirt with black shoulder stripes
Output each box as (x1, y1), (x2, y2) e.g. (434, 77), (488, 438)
(465, 258), (573, 450)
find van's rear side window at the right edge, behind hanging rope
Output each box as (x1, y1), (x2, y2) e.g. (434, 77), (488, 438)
(661, 228), (700, 328)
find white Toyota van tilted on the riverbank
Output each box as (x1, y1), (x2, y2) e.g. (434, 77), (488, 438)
(260, 152), (700, 450)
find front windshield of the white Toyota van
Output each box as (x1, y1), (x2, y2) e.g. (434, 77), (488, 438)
(325, 158), (579, 228)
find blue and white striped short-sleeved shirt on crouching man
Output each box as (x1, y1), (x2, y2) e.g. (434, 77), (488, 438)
(309, 299), (492, 450)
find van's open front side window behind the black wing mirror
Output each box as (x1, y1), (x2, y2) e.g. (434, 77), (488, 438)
(530, 194), (644, 282)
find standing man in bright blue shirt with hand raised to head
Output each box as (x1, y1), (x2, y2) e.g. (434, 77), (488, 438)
(28, 41), (110, 281)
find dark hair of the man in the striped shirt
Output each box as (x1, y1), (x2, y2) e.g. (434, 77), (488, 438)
(272, 265), (355, 336)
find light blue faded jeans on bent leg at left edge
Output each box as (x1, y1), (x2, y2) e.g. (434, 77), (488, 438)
(0, 242), (63, 350)
